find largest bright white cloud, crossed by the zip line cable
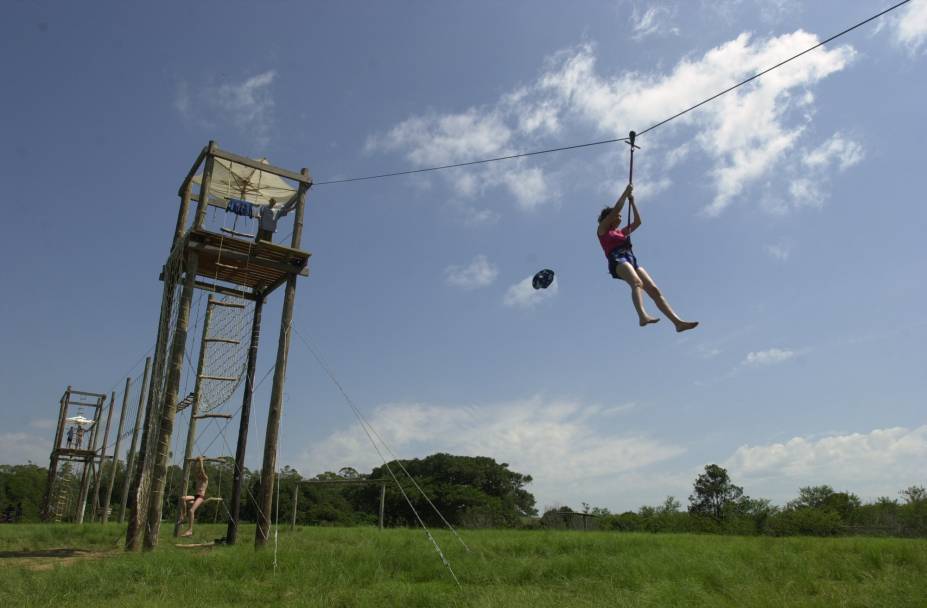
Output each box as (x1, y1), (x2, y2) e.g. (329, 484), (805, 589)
(367, 30), (861, 215)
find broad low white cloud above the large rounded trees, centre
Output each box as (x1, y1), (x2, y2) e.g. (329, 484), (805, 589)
(300, 397), (684, 506)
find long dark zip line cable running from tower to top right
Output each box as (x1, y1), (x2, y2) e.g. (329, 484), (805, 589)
(312, 0), (911, 186)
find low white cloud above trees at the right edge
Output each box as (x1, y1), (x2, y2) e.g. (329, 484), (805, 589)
(725, 426), (927, 499)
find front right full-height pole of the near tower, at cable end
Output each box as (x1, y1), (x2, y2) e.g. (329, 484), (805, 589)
(254, 169), (309, 547)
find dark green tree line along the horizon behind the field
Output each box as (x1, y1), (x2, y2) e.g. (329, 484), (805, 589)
(0, 453), (927, 536)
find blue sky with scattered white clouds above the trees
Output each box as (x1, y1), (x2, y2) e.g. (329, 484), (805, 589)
(0, 0), (927, 511)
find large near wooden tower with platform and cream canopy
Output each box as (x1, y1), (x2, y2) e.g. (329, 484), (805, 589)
(126, 141), (312, 550)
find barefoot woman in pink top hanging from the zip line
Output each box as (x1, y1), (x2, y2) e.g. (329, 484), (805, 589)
(596, 184), (698, 332)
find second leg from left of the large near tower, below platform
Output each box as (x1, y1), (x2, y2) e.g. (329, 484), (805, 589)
(143, 251), (199, 550)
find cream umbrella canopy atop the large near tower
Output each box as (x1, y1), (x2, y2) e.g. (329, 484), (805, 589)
(193, 158), (296, 207)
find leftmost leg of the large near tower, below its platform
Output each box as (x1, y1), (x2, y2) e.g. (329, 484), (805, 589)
(126, 250), (179, 551)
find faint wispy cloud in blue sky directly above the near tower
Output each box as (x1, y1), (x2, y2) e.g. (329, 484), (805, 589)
(174, 70), (276, 147)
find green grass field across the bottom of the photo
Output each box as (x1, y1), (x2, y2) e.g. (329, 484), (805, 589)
(0, 524), (927, 608)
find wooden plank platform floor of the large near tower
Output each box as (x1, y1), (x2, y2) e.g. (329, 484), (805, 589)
(181, 229), (311, 292)
